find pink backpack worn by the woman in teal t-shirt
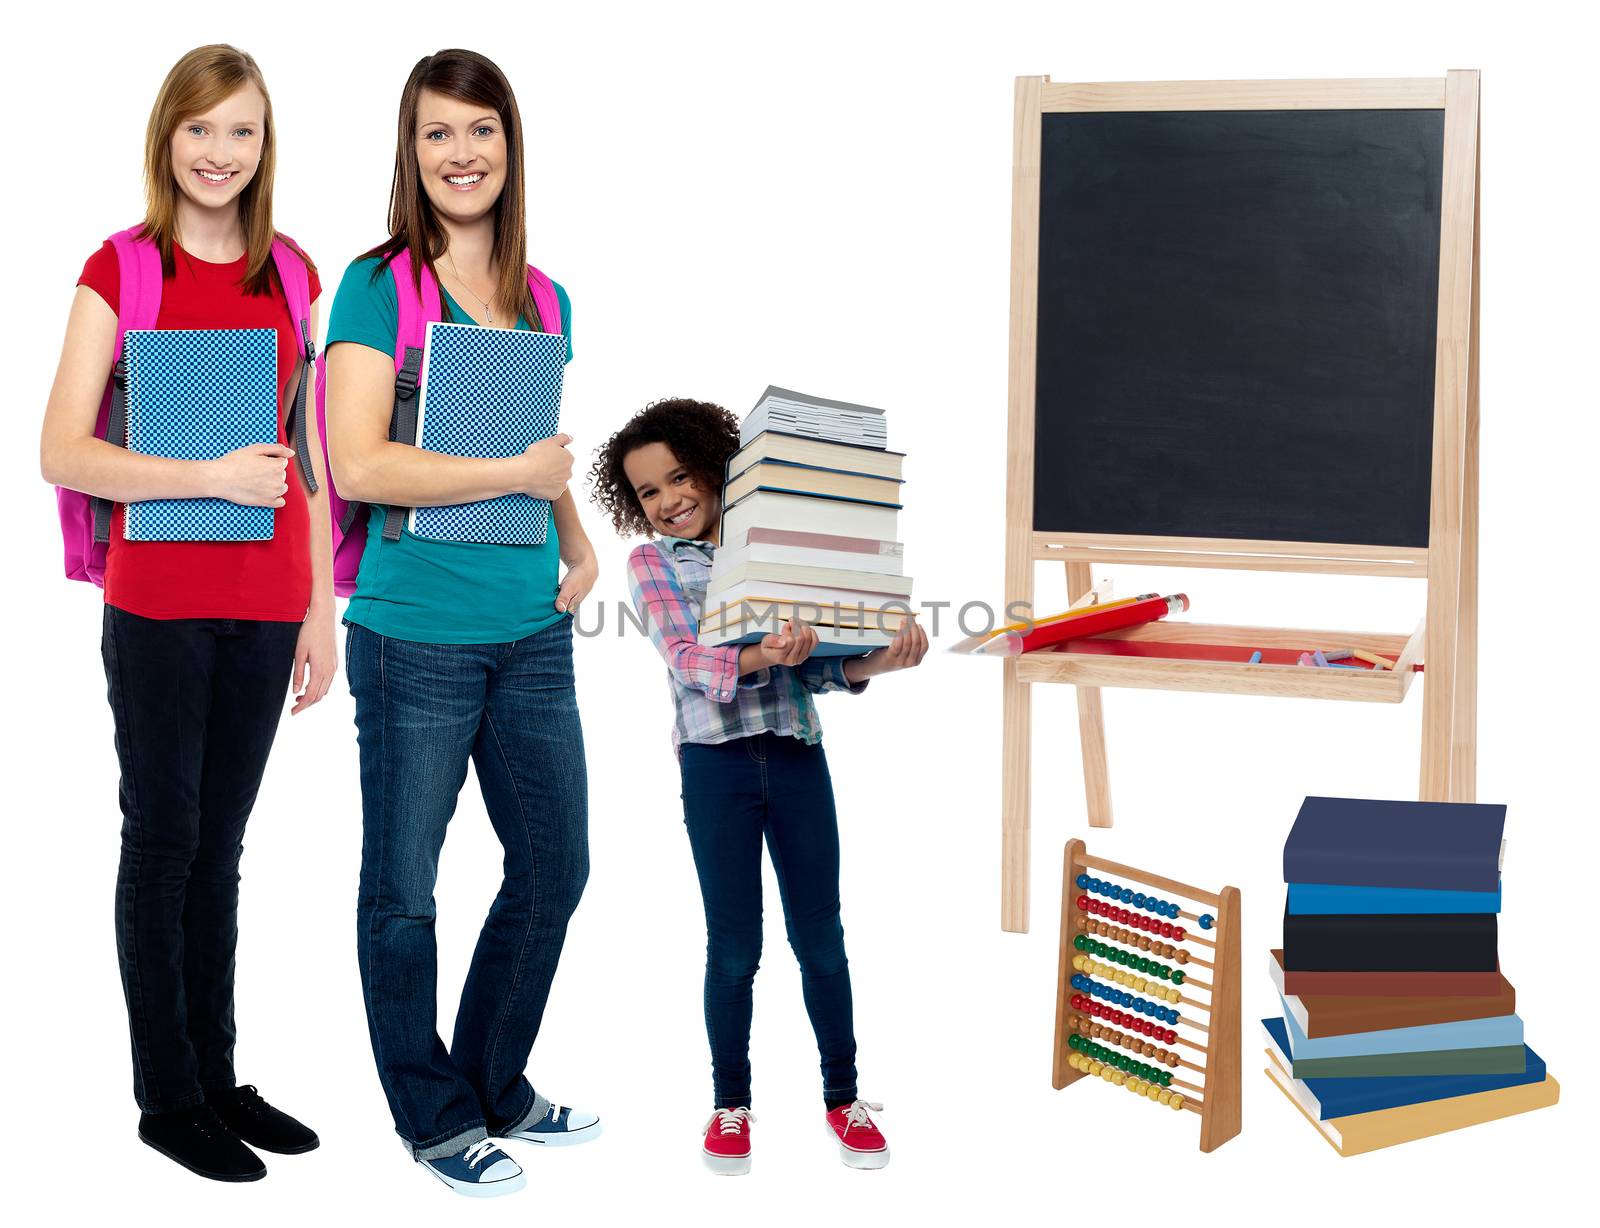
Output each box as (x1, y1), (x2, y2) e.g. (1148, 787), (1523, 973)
(317, 251), (562, 596)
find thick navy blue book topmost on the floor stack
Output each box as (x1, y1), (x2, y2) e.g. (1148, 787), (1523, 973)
(1283, 798), (1506, 891)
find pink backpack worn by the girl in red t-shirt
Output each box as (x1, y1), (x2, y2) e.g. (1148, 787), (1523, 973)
(56, 224), (317, 585)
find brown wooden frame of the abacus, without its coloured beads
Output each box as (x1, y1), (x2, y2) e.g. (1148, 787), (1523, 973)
(1053, 839), (1243, 1151)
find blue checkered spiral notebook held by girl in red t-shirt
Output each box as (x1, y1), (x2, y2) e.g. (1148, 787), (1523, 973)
(122, 328), (278, 542)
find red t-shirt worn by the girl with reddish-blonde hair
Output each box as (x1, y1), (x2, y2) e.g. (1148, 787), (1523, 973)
(78, 241), (322, 622)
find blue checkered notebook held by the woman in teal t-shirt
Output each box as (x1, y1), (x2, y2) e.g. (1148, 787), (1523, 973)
(408, 323), (566, 545)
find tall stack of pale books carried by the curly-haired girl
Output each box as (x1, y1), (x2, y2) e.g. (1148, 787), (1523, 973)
(699, 389), (914, 656)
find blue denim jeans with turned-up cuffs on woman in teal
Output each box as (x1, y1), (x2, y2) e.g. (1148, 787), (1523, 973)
(346, 619), (589, 1159)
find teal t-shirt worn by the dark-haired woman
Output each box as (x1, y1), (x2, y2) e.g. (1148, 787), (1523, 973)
(326, 256), (573, 644)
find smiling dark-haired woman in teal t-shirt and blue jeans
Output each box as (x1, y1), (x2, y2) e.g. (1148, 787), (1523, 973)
(326, 51), (600, 1196)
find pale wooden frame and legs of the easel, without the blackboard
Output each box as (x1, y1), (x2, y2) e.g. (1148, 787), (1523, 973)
(1000, 70), (1478, 932)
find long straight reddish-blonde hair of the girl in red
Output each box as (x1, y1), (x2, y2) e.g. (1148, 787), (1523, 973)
(139, 43), (300, 294)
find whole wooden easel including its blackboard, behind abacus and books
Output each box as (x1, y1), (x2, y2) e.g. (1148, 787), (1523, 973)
(1002, 72), (1478, 931)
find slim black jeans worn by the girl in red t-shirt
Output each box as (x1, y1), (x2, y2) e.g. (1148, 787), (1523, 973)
(101, 606), (301, 1113)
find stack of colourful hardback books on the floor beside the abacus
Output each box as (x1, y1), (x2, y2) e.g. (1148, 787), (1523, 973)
(1262, 798), (1560, 1156)
